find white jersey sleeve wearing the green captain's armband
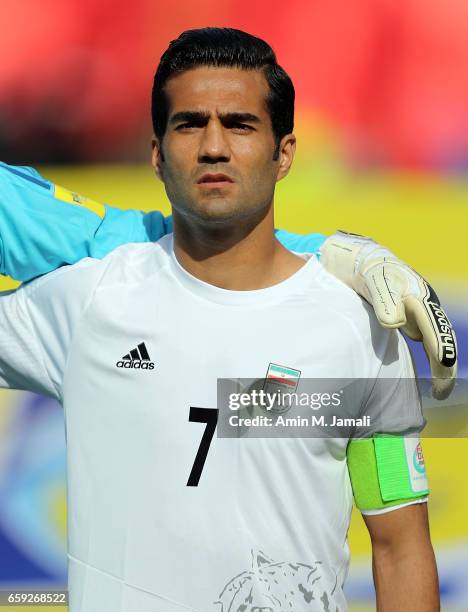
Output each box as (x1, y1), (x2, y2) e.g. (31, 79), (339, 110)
(347, 330), (429, 514)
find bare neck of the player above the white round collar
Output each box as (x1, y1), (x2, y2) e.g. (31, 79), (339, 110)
(173, 206), (304, 291)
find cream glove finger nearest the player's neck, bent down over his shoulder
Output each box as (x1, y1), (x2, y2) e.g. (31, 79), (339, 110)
(364, 264), (406, 328)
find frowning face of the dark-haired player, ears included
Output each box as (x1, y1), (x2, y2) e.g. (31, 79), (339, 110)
(153, 67), (295, 223)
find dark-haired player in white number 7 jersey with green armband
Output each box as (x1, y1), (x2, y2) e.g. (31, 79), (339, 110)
(0, 28), (438, 612)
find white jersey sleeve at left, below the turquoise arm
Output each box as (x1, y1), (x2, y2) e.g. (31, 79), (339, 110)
(0, 258), (106, 400)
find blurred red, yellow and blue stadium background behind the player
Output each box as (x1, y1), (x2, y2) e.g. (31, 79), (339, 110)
(0, 0), (468, 612)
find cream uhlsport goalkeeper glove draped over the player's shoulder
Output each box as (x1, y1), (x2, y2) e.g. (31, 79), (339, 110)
(320, 231), (457, 399)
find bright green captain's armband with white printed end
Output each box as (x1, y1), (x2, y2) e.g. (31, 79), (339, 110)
(346, 434), (429, 510)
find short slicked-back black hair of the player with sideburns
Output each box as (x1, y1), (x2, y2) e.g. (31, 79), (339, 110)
(151, 28), (294, 159)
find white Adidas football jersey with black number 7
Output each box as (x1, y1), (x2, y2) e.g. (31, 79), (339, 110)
(0, 236), (422, 612)
